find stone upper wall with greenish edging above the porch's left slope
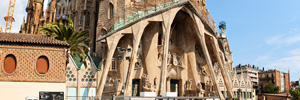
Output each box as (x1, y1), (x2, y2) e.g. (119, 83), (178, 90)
(107, 0), (179, 32)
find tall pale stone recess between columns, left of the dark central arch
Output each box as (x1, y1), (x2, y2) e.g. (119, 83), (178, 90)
(138, 22), (162, 91)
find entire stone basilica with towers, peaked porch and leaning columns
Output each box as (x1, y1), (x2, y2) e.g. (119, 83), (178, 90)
(2, 0), (255, 100)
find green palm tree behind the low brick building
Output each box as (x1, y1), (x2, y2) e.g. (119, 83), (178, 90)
(40, 18), (91, 65)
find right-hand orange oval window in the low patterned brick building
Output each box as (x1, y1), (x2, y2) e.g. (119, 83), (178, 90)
(36, 56), (49, 74)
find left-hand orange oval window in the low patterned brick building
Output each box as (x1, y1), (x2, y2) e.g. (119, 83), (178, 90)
(4, 54), (17, 73)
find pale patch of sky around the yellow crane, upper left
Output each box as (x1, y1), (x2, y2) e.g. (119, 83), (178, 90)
(0, 0), (27, 32)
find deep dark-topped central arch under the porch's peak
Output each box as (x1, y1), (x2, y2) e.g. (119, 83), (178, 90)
(168, 8), (203, 96)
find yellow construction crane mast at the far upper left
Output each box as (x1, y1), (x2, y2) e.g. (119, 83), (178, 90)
(4, 0), (16, 32)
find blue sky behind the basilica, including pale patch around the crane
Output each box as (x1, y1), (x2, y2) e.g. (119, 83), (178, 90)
(0, 0), (300, 81)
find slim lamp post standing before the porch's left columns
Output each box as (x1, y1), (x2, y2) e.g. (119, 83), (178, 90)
(117, 47), (131, 99)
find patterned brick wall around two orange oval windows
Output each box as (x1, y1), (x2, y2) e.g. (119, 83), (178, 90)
(0, 44), (66, 83)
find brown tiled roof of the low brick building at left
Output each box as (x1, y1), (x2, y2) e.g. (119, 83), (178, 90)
(0, 32), (69, 46)
